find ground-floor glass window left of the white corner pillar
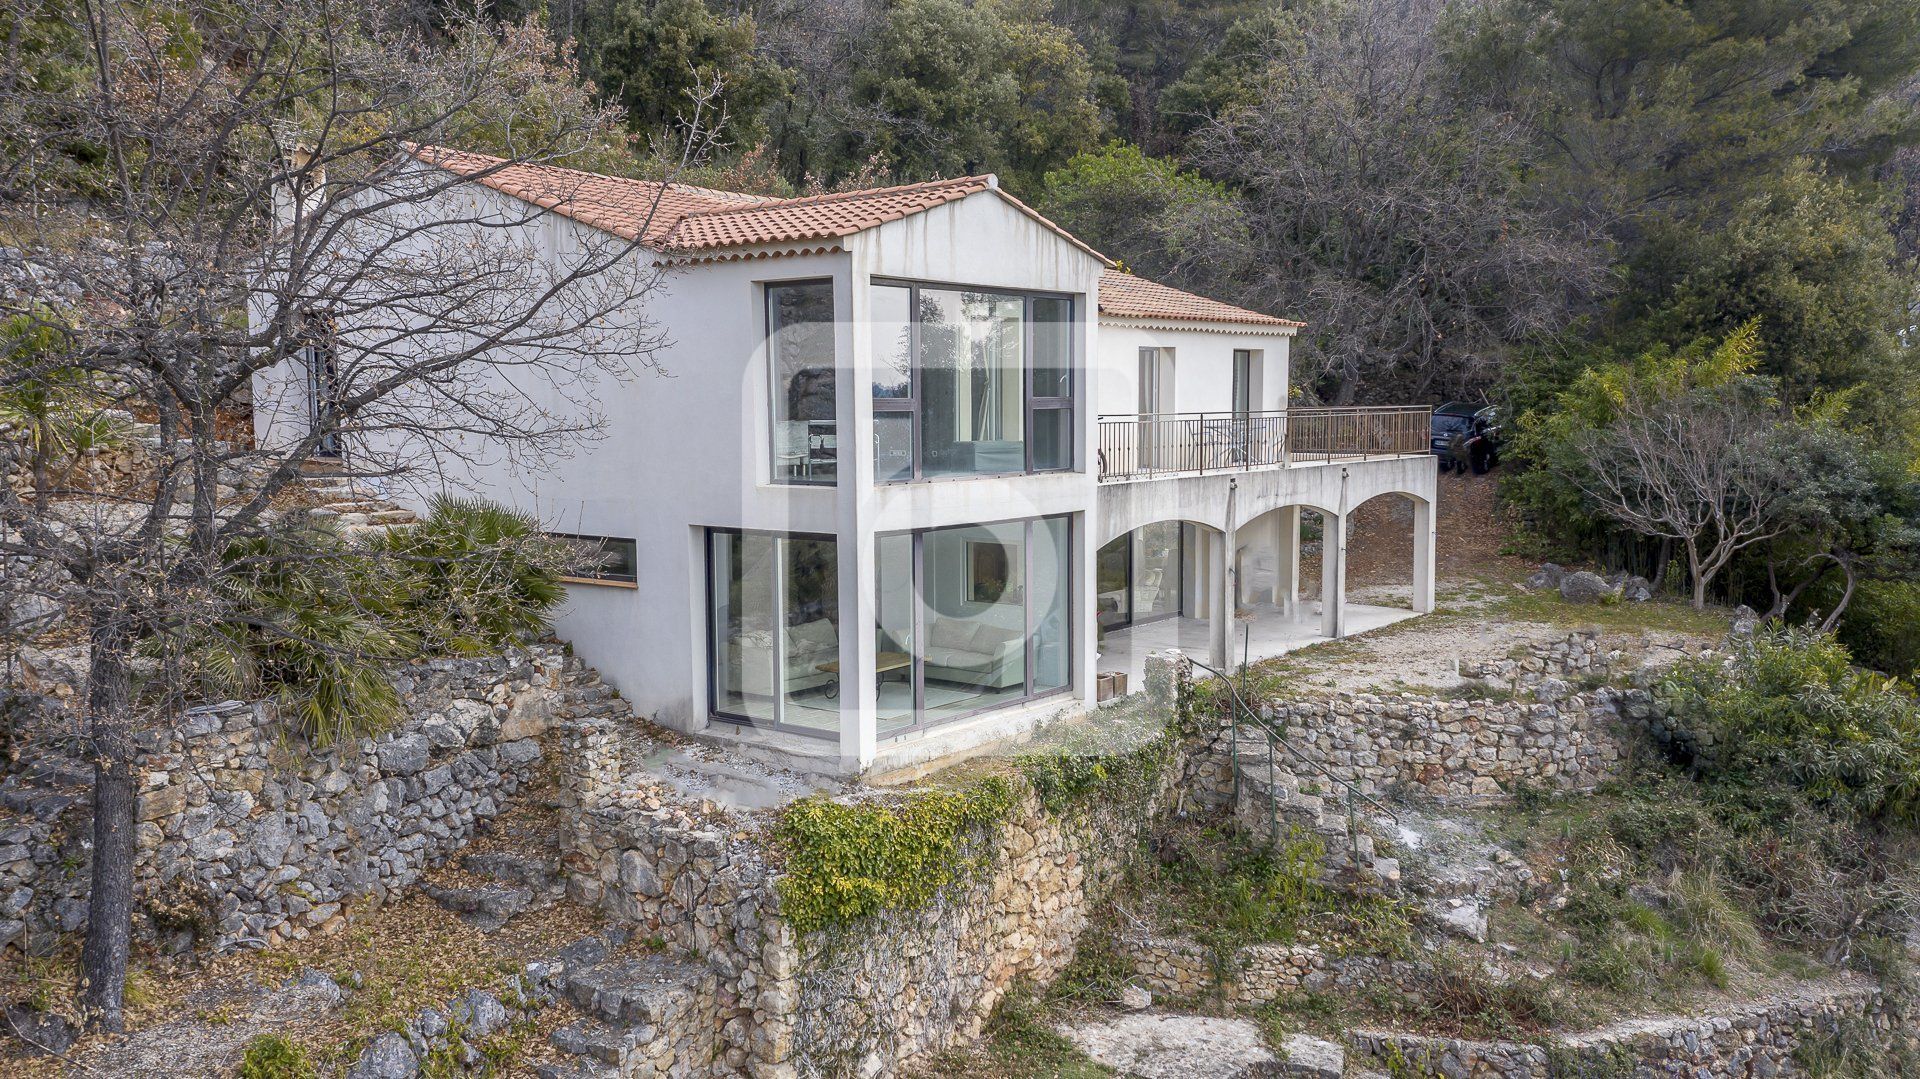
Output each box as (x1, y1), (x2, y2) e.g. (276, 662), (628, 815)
(707, 530), (839, 737)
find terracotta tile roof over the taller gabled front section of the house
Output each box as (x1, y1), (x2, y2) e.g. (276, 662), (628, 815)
(415, 146), (1106, 261)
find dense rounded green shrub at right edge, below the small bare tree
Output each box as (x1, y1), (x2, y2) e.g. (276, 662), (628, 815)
(1665, 630), (1920, 824)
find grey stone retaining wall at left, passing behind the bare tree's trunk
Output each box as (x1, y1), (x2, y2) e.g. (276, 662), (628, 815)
(0, 645), (599, 950)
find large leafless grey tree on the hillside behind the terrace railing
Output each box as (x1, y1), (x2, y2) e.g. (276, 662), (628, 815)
(1194, 0), (1605, 405)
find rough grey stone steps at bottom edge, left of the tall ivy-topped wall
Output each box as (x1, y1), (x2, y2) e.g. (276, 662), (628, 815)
(534, 937), (720, 1079)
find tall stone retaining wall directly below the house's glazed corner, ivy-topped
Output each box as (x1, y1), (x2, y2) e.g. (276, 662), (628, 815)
(568, 767), (1150, 1079)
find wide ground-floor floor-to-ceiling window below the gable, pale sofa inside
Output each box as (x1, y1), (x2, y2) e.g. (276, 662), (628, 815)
(874, 516), (1073, 737)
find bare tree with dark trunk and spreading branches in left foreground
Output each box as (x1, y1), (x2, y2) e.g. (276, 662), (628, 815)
(0, 0), (698, 1029)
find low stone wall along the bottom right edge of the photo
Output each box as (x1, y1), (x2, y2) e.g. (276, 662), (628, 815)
(1350, 979), (1910, 1079)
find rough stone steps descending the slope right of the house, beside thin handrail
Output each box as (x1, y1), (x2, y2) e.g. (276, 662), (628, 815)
(1233, 731), (1402, 895)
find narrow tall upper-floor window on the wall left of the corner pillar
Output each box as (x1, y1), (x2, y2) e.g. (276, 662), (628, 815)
(766, 280), (839, 484)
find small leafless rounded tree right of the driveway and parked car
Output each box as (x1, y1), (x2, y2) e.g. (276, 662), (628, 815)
(1563, 384), (1795, 609)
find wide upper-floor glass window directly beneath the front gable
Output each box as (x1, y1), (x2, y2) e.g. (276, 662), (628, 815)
(872, 284), (1073, 482)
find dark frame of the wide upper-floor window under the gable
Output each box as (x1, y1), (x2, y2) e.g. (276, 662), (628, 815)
(866, 276), (1083, 486)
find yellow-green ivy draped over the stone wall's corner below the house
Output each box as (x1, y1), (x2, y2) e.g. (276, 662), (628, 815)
(774, 778), (1016, 933)
